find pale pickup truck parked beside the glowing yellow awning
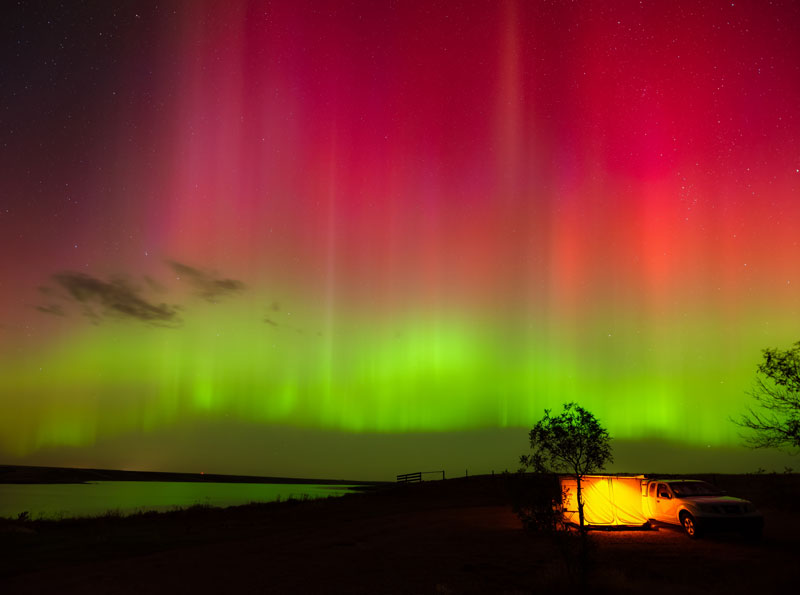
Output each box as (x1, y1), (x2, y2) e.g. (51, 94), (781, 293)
(642, 479), (764, 539)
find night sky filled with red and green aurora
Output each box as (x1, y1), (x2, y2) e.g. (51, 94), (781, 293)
(0, 0), (800, 478)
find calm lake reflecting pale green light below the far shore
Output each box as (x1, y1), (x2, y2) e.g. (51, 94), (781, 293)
(0, 481), (354, 518)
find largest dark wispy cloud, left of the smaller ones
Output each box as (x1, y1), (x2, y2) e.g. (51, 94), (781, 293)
(52, 271), (180, 326)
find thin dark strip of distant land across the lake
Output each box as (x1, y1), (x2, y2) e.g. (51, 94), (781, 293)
(0, 465), (385, 485)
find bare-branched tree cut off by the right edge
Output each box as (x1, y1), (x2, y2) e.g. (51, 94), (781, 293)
(734, 341), (800, 452)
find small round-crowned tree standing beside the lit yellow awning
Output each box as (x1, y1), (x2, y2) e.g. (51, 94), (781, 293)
(520, 403), (614, 534)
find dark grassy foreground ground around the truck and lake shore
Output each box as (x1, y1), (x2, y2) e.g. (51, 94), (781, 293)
(0, 476), (800, 595)
